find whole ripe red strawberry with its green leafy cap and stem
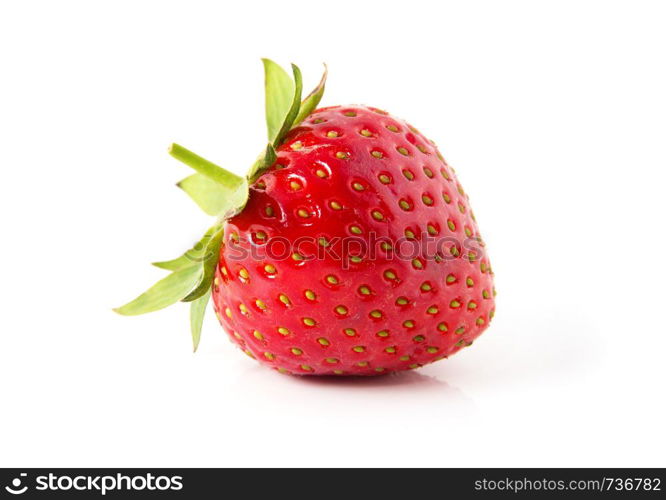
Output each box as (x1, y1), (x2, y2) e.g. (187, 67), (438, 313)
(118, 60), (495, 375)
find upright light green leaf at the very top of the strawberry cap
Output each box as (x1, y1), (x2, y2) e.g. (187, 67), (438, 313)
(262, 59), (294, 142)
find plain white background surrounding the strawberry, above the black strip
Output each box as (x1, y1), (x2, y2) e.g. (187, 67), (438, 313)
(0, 0), (666, 467)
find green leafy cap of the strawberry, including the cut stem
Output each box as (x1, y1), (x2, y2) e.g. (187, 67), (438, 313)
(114, 59), (327, 351)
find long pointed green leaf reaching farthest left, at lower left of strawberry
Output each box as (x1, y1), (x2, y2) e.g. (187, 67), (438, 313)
(114, 266), (202, 316)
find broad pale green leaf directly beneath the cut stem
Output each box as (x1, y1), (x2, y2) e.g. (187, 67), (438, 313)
(176, 174), (249, 216)
